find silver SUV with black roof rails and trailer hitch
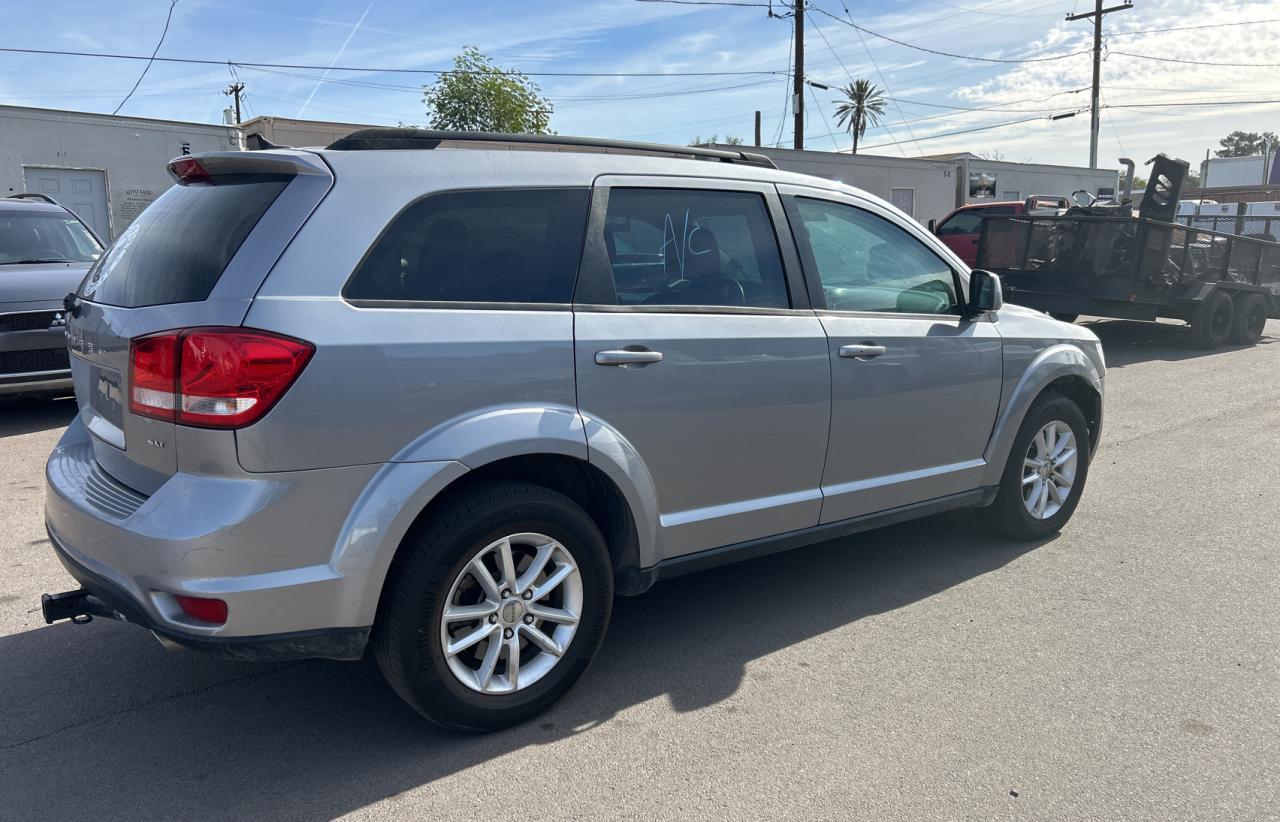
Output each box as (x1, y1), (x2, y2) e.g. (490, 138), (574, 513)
(44, 129), (1103, 730)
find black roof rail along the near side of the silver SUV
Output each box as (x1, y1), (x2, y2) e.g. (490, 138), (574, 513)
(326, 128), (777, 169)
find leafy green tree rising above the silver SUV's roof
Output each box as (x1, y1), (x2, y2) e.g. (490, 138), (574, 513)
(422, 46), (552, 134)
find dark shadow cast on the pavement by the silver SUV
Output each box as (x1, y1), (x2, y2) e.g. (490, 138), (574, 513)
(0, 511), (1043, 819)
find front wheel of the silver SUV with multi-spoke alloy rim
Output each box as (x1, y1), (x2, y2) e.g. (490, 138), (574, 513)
(979, 392), (1089, 540)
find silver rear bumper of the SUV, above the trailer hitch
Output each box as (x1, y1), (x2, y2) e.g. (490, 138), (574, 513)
(45, 417), (376, 658)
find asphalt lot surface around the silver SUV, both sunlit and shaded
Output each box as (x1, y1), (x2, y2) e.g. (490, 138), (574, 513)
(0, 314), (1280, 822)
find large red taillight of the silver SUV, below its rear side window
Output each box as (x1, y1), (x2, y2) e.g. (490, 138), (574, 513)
(129, 328), (315, 428)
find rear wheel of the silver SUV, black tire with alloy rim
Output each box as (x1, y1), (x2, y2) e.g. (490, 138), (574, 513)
(372, 481), (613, 732)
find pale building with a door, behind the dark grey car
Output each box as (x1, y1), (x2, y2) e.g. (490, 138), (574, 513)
(0, 105), (241, 242)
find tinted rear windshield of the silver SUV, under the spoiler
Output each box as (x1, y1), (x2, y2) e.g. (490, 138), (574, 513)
(81, 177), (289, 309)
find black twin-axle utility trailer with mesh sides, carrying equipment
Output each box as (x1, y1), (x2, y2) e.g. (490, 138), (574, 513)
(977, 214), (1280, 348)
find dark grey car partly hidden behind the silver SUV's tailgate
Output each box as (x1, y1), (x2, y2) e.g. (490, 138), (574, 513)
(0, 196), (102, 394)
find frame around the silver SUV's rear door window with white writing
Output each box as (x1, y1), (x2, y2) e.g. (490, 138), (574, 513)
(573, 174), (813, 316)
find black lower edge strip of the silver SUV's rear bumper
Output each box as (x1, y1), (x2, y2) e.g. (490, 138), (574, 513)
(46, 531), (369, 661)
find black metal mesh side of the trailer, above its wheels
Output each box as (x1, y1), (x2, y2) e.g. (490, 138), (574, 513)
(978, 216), (1280, 296)
